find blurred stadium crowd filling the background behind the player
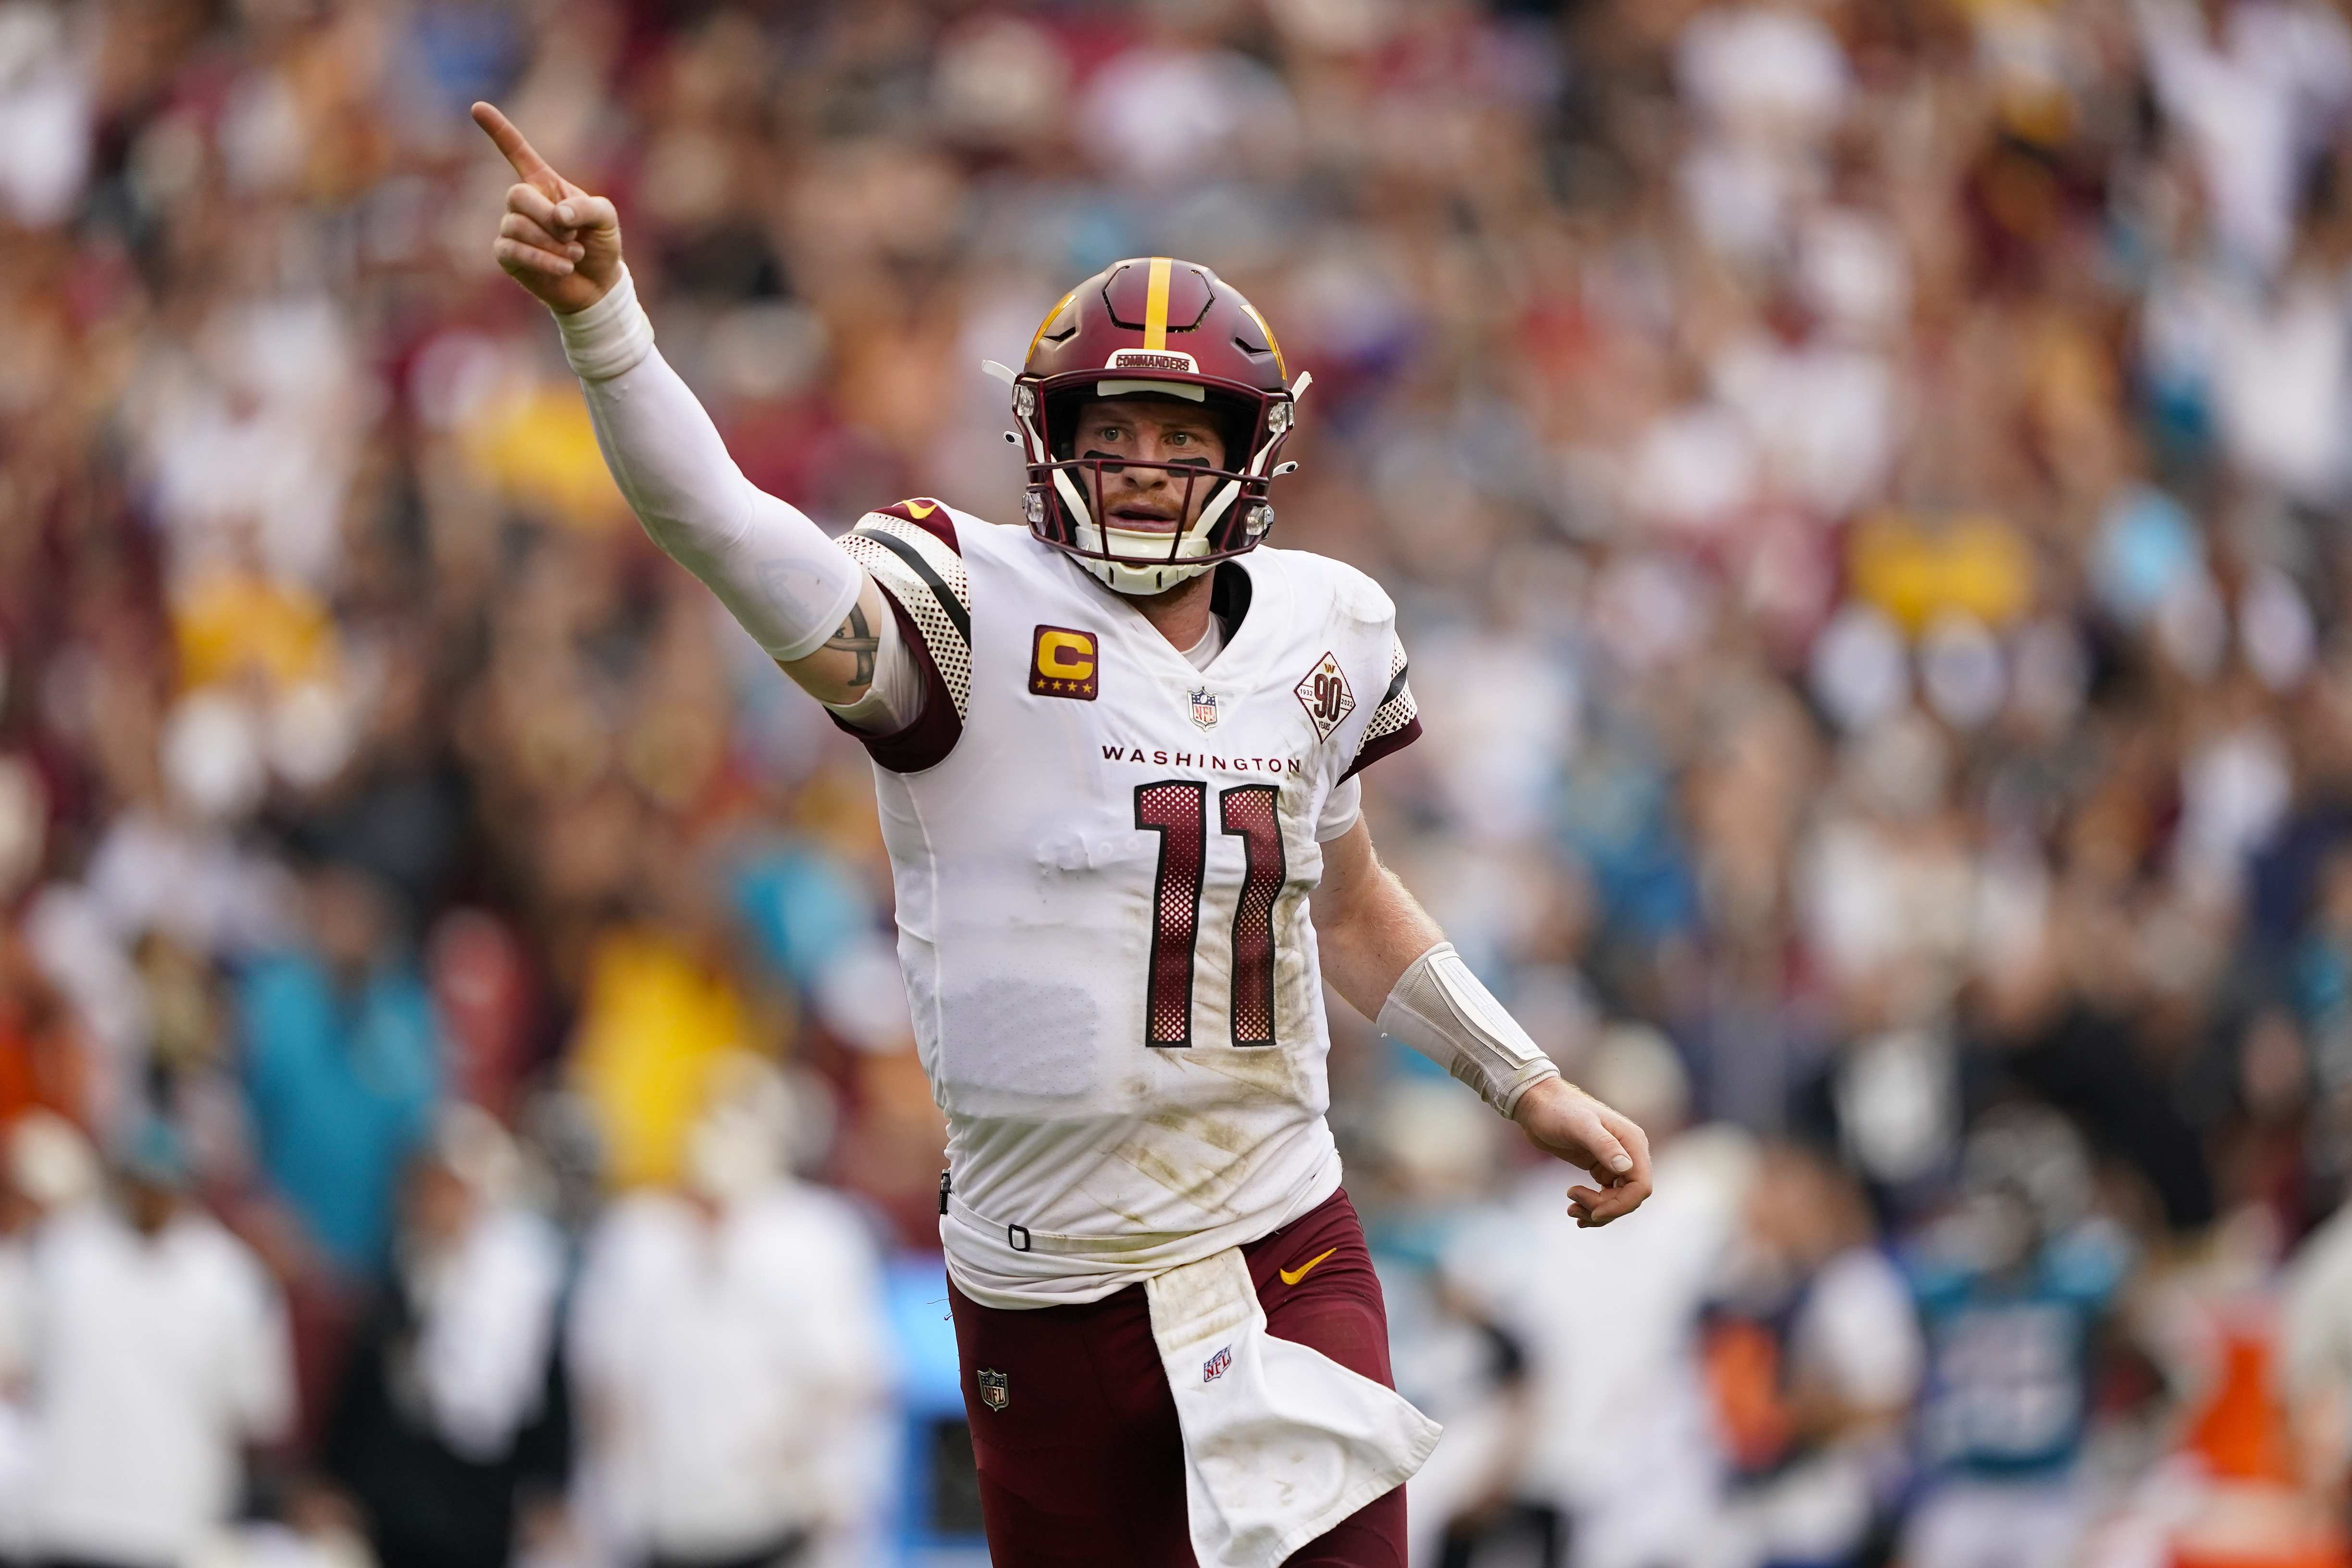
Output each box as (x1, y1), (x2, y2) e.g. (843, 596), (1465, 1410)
(0, 0), (2352, 1568)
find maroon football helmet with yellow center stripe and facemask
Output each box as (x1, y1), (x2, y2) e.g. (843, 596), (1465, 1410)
(990, 256), (1308, 595)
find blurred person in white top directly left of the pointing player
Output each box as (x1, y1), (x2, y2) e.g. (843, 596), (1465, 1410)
(572, 1053), (889, 1568)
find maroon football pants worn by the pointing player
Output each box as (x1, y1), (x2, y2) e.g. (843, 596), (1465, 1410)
(948, 1192), (1404, 1568)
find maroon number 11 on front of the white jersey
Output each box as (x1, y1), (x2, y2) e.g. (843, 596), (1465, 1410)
(1136, 778), (1286, 1049)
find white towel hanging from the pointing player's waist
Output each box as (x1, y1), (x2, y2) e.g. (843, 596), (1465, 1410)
(1143, 1248), (1439, 1568)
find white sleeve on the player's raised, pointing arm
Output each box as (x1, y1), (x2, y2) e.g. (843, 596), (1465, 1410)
(555, 270), (866, 663)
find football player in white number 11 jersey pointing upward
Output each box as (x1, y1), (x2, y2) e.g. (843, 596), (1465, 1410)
(473, 103), (1649, 1566)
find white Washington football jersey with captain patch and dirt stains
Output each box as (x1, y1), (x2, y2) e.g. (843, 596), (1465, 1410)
(842, 501), (1421, 1307)
